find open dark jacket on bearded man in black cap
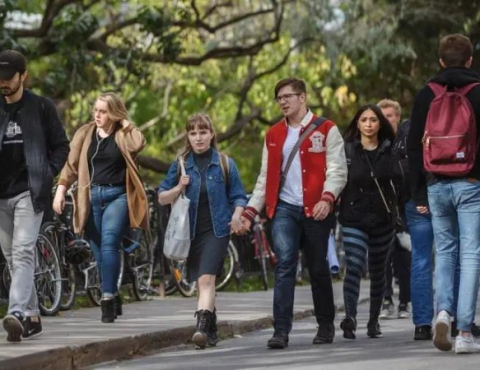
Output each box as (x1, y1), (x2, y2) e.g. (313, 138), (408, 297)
(0, 90), (70, 213)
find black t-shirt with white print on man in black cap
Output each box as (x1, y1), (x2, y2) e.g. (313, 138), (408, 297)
(0, 97), (28, 199)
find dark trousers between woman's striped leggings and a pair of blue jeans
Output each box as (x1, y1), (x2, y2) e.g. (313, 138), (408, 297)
(385, 237), (411, 303)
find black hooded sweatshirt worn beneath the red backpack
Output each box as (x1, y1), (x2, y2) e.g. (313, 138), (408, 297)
(407, 67), (480, 206)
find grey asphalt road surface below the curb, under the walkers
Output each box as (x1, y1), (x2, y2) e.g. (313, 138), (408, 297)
(92, 298), (480, 370)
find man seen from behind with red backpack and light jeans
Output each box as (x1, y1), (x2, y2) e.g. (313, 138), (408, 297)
(407, 34), (480, 353)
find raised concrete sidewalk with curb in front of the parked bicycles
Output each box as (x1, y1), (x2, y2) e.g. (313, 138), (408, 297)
(0, 281), (369, 370)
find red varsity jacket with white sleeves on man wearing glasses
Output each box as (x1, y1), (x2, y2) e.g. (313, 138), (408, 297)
(243, 111), (348, 221)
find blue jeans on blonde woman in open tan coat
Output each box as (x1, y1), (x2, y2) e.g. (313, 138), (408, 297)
(85, 186), (129, 297)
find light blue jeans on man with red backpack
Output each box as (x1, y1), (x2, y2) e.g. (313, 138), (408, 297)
(428, 179), (480, 332)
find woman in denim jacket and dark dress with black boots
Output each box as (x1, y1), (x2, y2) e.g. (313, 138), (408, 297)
(158, 114), (247, 349)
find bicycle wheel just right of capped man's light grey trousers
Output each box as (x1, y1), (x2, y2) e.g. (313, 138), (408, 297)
(35, 234), (62, 316)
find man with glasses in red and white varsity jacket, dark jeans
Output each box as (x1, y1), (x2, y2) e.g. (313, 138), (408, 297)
(242, 78), (347, 349)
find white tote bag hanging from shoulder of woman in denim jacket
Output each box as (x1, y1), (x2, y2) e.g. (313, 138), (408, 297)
(163, 158), (190, 261)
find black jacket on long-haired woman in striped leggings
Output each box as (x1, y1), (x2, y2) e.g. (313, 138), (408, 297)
(339, 140), (397, 230)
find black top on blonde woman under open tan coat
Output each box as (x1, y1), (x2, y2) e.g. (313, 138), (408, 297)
(87, 130), (127, 185)
